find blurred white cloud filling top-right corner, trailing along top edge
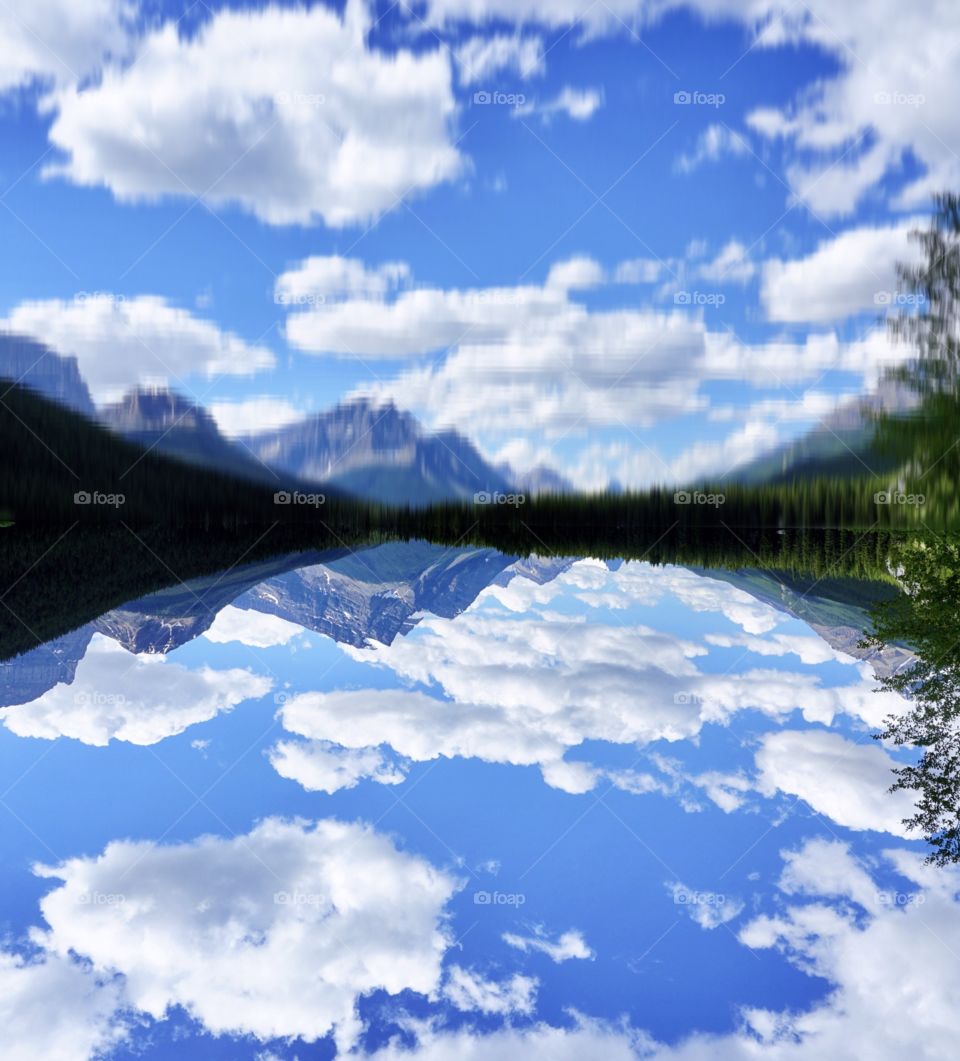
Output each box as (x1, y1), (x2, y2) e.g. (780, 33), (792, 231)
(413, 0), (960, 215)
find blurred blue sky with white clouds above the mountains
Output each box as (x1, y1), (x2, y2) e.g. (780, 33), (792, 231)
(0, 0), (946, 488)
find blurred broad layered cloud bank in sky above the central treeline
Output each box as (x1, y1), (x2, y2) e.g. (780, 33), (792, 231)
(269, 250), (909, 489)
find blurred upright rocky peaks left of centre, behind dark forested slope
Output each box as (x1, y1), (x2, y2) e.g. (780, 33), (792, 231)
(0, 334), (572, 507)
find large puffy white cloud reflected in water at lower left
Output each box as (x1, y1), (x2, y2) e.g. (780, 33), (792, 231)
(36, 818), (458, 1050)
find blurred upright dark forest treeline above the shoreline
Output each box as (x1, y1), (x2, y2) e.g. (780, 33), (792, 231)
(0, 377), (955, 534)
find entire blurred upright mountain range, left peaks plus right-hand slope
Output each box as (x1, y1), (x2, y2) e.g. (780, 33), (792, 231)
(0, 333), (915, 496)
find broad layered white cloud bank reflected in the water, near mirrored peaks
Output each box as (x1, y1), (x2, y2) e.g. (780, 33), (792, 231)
(272, 561), (902, 802)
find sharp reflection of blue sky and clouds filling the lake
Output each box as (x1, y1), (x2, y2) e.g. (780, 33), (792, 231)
(0, 560), (960, 1061)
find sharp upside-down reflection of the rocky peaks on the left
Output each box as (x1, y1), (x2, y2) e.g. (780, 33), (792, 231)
(0, 542), (576, 707)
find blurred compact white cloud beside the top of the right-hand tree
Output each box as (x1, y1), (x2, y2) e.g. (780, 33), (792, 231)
(761, 218), (922, 321)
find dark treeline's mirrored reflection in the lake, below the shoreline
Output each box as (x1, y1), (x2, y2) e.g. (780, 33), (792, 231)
(0, 524), (891, 659)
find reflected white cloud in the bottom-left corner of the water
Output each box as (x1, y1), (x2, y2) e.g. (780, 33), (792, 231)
(0, 951), (125, 1061)
